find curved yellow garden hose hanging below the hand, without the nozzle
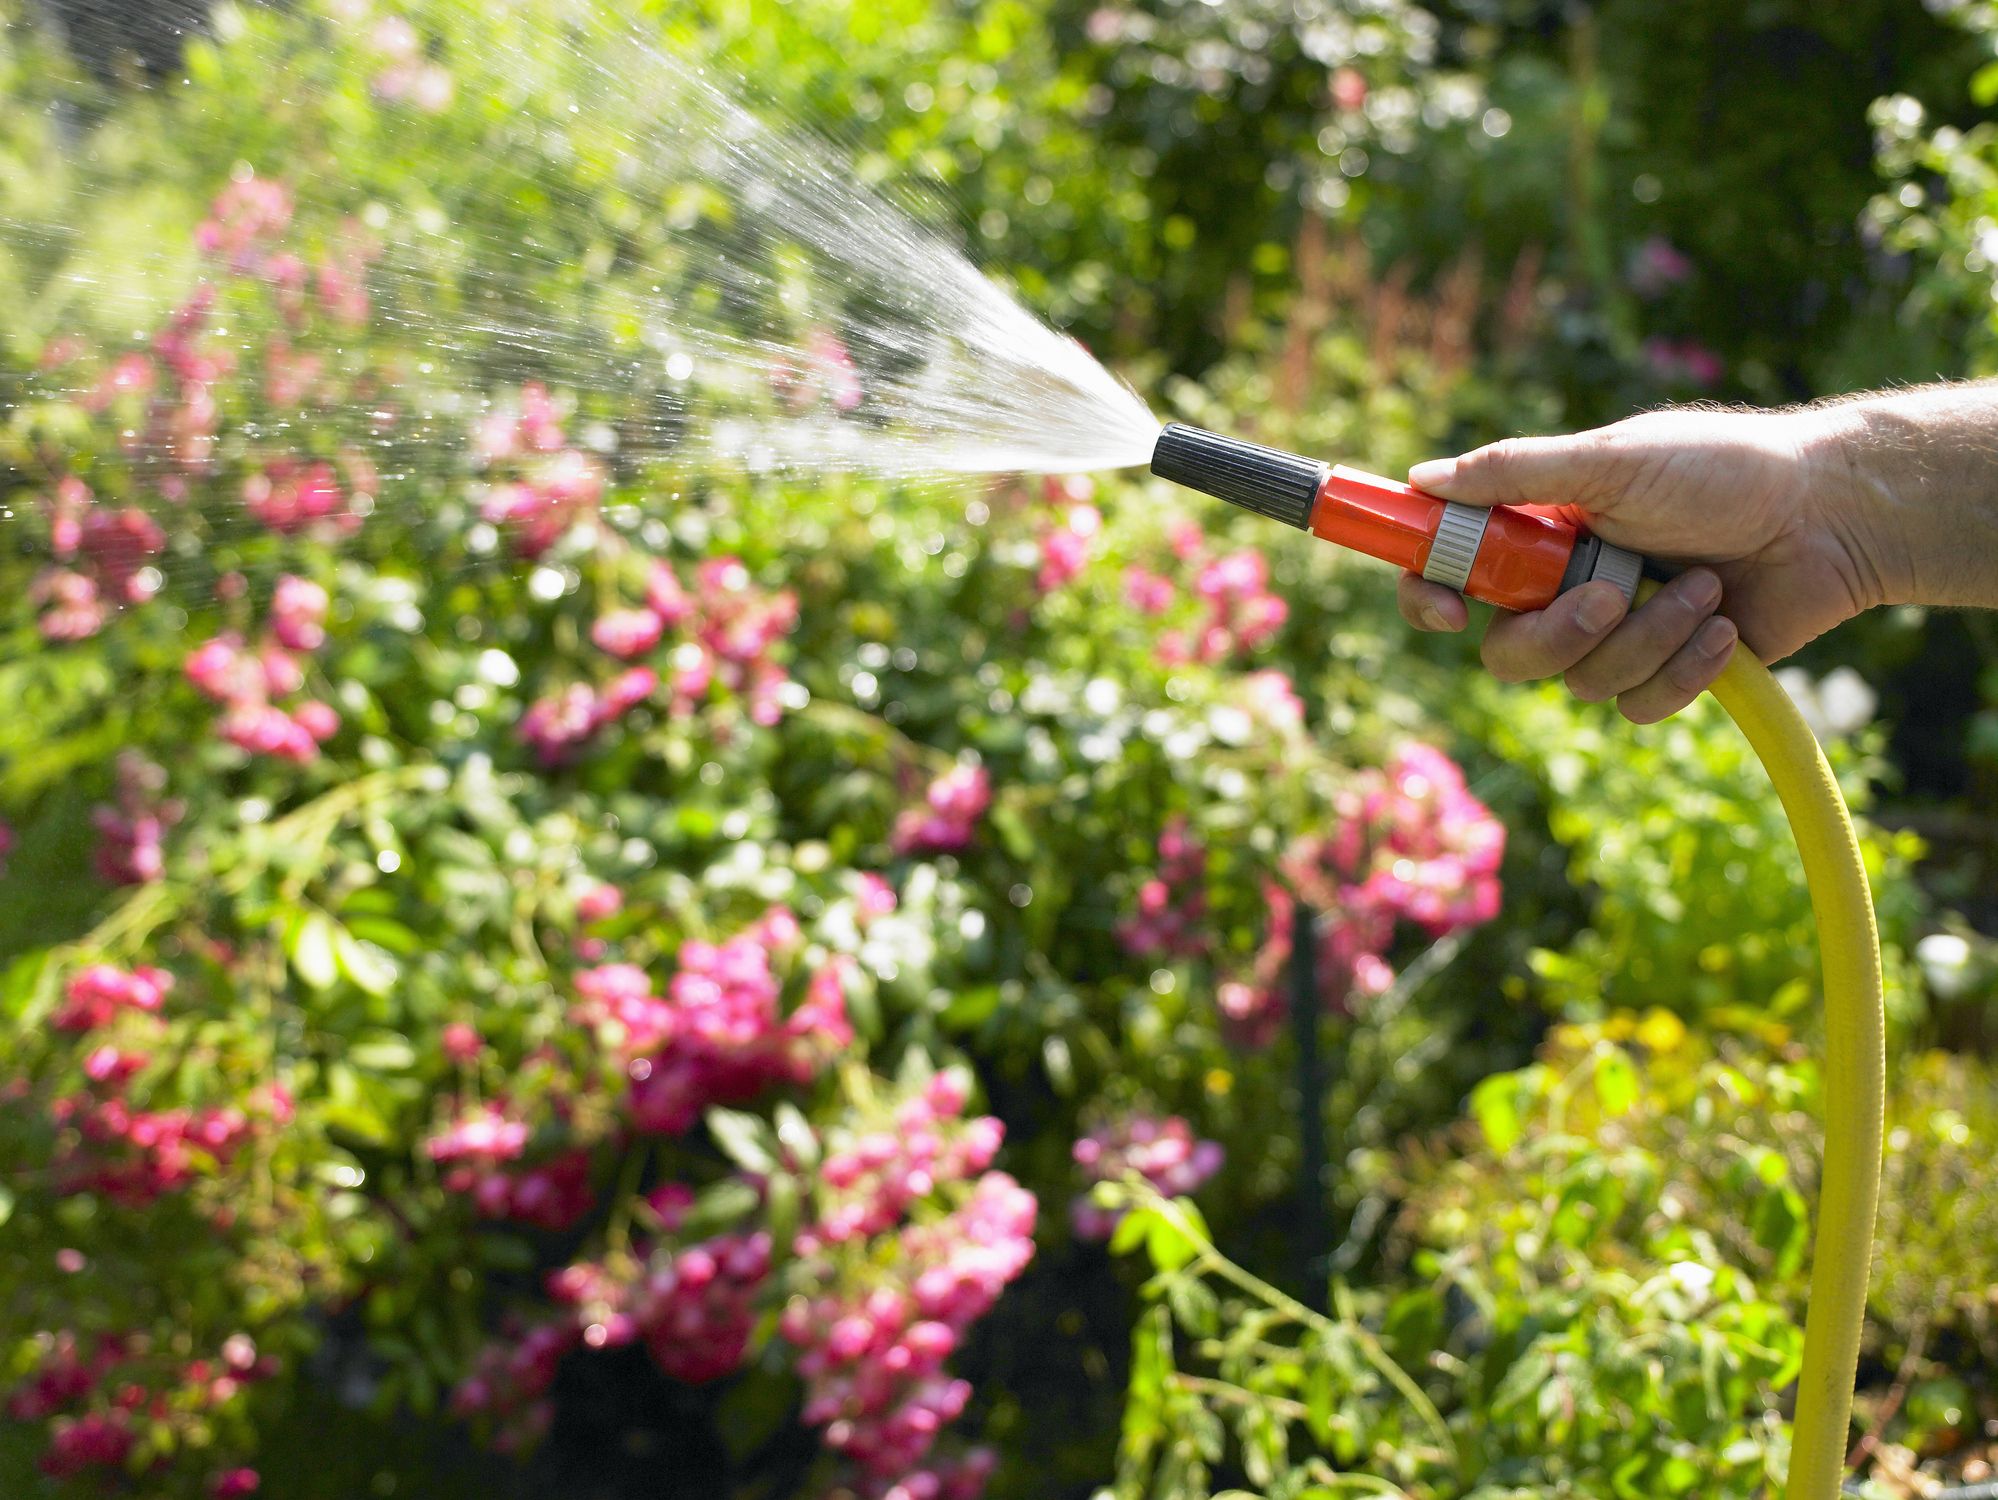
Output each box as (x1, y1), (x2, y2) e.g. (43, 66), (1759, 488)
(1712, 619), (1886, 1500)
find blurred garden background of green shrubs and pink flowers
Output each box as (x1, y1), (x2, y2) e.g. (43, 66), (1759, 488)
(0, 0), (1998, 1500)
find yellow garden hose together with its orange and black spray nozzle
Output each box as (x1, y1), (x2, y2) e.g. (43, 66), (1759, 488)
(1151, 423), (1886, 1500)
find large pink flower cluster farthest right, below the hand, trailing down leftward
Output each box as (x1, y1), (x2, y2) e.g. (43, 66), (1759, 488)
(1217, 745), (1504, 1045)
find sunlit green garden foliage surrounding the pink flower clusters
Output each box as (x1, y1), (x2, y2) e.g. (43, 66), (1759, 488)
(0, 0), (1974, 1500)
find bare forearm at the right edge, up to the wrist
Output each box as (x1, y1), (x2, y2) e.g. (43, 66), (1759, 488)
(1800, 379), (1998, 607)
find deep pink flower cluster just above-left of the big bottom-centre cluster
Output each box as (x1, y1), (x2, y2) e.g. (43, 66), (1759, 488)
(573, 907), (853, 1134)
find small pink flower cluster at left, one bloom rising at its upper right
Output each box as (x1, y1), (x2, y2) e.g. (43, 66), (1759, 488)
(184, 575), (340, 763)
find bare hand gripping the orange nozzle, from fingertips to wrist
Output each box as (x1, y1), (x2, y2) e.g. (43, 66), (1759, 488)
(1401, 409), (1882, 723)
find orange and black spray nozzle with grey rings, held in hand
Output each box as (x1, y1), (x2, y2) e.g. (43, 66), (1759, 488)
(1151, 421), (1644, 609)
